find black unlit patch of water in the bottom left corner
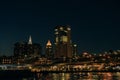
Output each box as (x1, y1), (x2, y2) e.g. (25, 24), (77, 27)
(0, 70), (37, 80)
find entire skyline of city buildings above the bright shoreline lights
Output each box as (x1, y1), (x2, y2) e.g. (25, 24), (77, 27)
(0, 25), (120, 71)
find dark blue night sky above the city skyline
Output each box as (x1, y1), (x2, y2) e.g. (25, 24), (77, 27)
(0, 0), (120, 55)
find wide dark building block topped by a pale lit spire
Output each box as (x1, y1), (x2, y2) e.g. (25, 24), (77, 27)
(14, 36), (41, 58)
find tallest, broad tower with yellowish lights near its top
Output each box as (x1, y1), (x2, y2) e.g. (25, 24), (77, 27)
(54, 25), (72, 58)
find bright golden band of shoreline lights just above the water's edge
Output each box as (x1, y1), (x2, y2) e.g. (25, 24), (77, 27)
(31, 62), (105, 72)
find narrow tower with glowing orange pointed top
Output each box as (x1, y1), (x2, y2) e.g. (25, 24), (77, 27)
(45, 40), (53, 58)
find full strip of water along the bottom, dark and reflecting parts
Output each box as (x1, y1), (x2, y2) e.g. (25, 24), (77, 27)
(0, 71), (120, 80)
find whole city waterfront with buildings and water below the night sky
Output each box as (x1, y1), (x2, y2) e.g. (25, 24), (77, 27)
(0, 25), (120, 80)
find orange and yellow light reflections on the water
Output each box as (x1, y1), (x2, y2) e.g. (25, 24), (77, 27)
(37, 72), (120, 80)
